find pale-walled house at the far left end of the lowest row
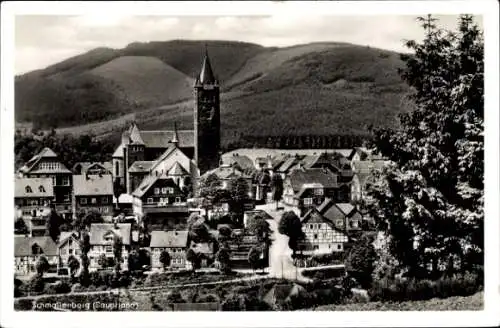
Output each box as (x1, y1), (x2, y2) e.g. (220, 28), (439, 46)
(14, 236), (59, 276)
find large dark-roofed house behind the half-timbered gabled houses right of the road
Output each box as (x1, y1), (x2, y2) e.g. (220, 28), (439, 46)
(283, 168), (350, 216)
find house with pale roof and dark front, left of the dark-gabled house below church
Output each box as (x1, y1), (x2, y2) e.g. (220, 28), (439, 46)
(73, 174), (113, 219)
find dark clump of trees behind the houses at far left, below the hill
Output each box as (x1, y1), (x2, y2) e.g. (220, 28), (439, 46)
(14, 130), (117, 170)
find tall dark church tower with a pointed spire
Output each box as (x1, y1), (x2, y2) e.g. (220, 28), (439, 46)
(194, 49), (220, 174)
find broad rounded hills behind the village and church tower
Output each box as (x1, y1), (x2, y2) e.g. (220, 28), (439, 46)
(15, 40), (411, 149)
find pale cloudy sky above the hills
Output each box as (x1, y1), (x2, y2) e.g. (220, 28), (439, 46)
(15, 12), (482, 74)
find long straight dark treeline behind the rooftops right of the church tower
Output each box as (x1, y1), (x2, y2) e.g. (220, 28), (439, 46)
(225, 134), (370, 151)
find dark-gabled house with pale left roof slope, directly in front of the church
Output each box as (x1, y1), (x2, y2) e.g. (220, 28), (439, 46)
(132, 174), (189, 230)
